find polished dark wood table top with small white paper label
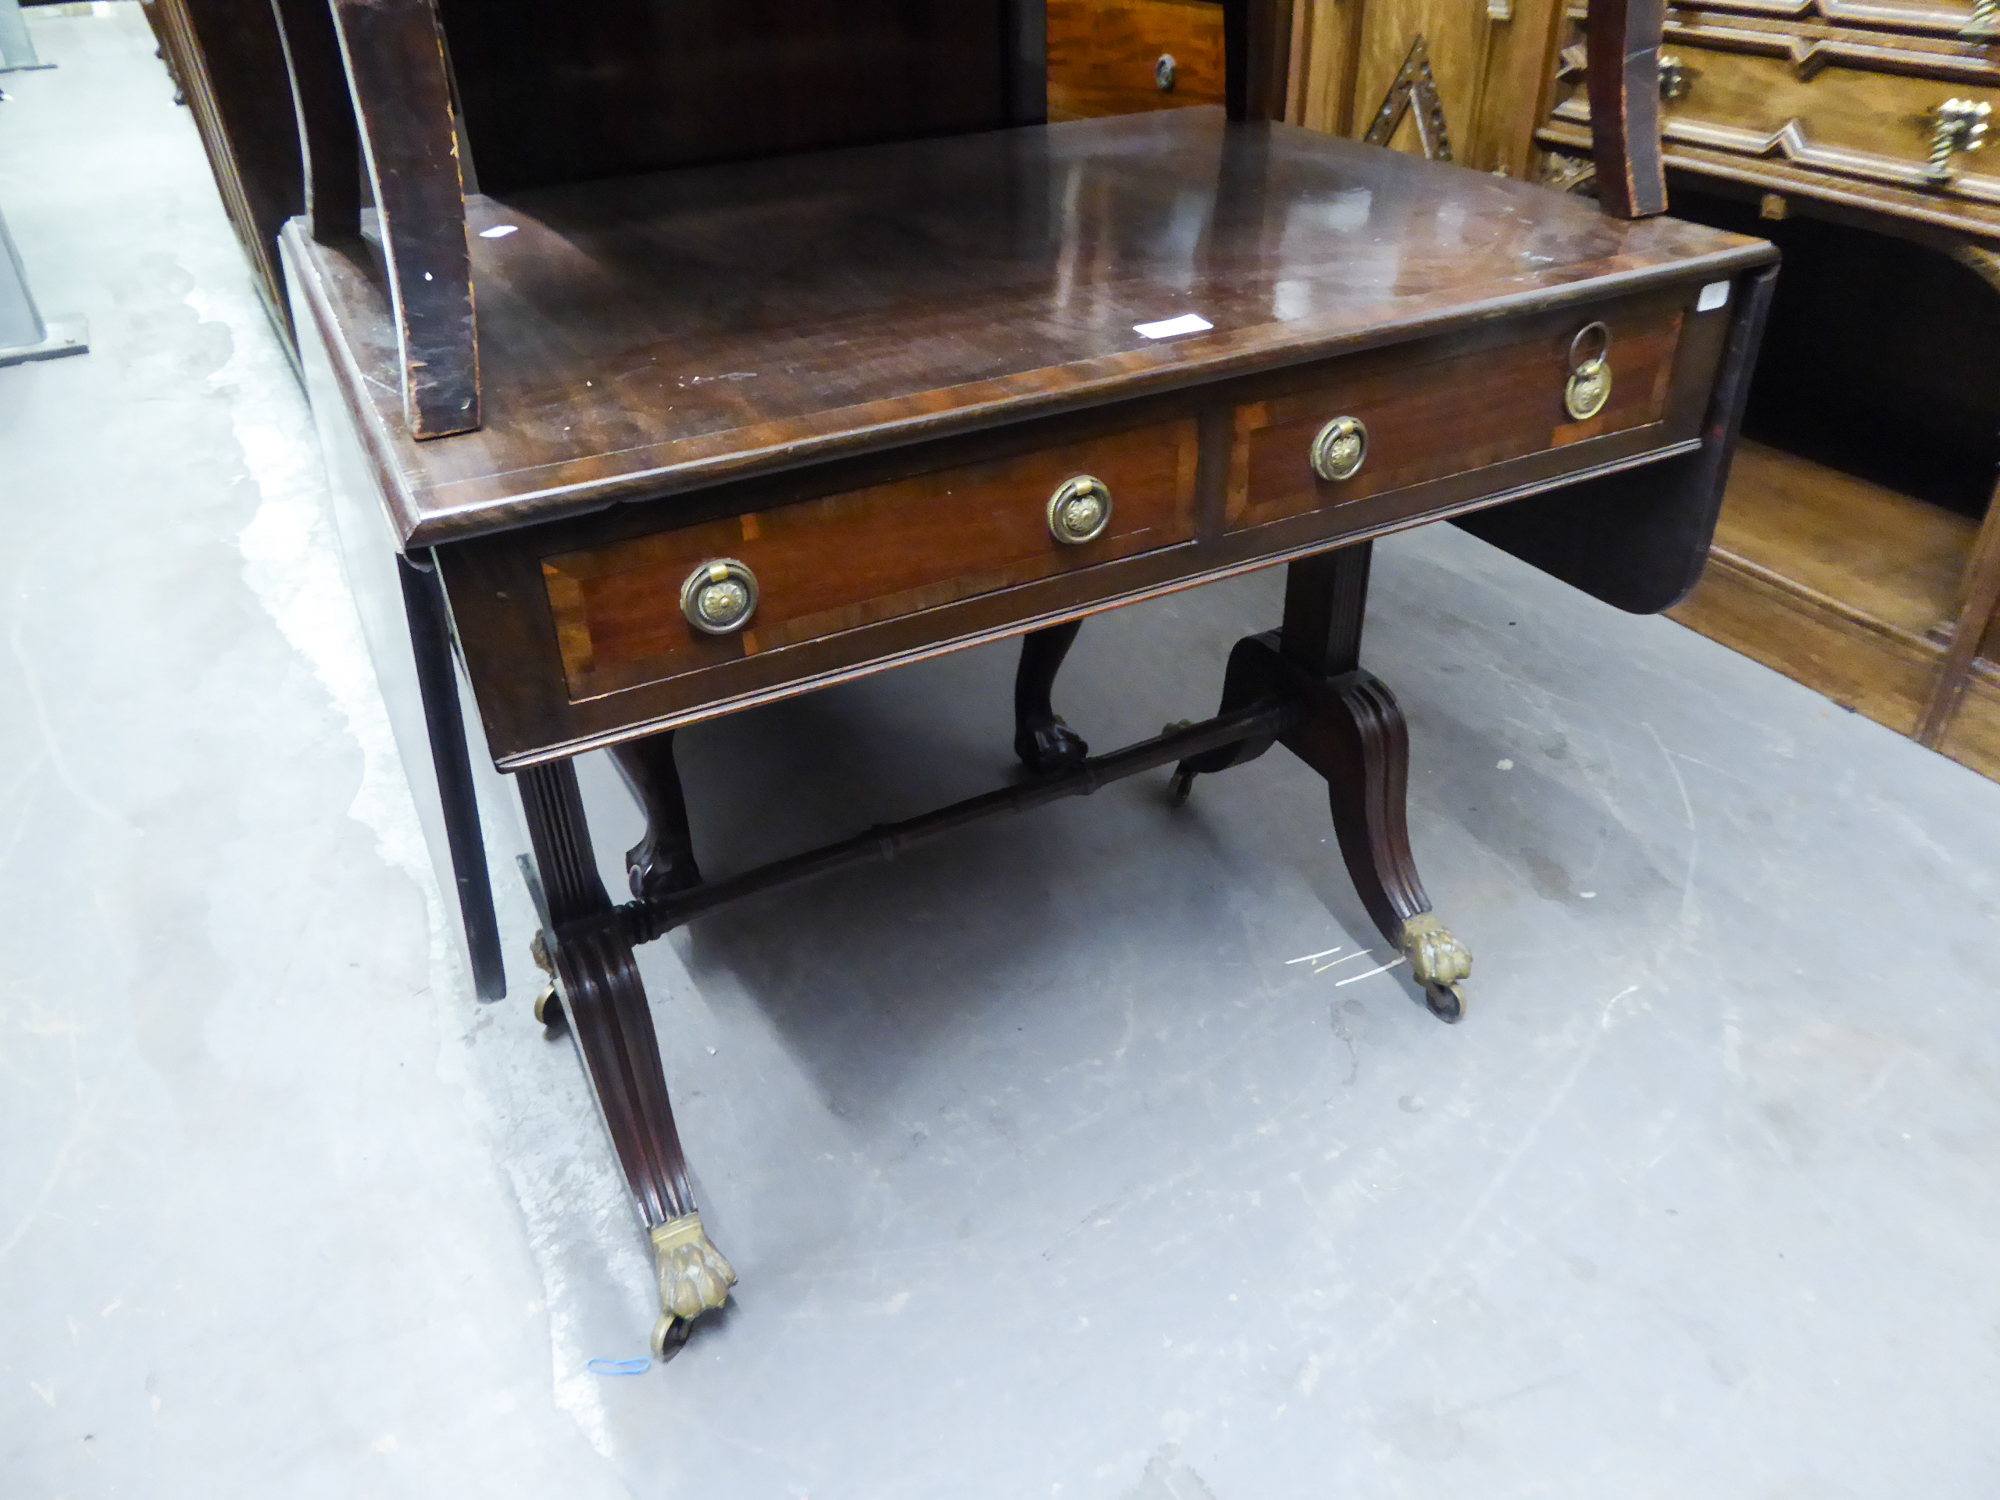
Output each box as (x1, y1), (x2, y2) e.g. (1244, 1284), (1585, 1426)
(286, 108), (1770, 546)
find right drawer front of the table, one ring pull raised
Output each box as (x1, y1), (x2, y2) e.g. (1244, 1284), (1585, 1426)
(1226, 296), (1684, 530)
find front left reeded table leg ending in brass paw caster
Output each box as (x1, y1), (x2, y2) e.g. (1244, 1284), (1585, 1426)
(520, 760), (736, 1358)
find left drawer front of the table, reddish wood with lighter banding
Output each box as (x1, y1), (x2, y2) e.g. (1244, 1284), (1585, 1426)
(542, 420), (1196, 702)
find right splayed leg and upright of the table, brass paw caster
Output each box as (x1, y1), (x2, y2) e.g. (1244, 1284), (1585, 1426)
(1174, 542), (1472, 1020)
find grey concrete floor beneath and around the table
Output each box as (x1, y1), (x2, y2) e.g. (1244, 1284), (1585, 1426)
(0, 4), (2000, 1500)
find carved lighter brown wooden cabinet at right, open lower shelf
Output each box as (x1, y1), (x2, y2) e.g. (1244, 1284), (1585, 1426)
(1538, 0), (2000, 778)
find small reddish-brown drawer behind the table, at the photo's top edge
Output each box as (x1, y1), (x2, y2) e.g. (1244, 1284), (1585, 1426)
(1048, 0), (1222, 120)
